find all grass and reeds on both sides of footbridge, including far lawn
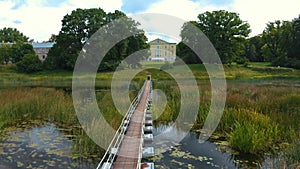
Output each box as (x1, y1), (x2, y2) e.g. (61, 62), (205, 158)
(0, 63), (300, 163)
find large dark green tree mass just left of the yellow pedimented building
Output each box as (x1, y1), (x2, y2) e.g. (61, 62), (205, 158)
(44, 8), (148, 71)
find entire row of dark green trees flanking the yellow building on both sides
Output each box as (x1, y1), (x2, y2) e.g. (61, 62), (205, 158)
(0, 8), (300, 72)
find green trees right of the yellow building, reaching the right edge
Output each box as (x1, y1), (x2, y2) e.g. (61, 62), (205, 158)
(177, 10), (300, 69)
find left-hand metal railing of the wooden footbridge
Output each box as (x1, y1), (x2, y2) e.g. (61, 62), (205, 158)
(96, 81), (146, 169)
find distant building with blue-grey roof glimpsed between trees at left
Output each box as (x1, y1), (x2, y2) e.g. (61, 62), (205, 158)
(31, 42), (54, 61)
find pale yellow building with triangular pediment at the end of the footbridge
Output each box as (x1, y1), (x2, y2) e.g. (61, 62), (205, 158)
(148, 39), (176, 62)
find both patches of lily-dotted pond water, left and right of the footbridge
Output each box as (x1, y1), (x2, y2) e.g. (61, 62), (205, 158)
(0, 122), (286, 169)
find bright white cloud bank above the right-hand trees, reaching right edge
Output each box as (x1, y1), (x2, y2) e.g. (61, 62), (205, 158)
(133, 0), (300, 40)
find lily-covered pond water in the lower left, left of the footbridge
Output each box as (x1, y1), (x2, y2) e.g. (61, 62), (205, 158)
(0, 122), (96, 169)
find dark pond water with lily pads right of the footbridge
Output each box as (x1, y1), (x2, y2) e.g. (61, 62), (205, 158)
(148, 125), (281, 169)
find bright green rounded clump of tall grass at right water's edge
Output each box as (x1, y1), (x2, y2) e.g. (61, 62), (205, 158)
(228, 110), (280, 153)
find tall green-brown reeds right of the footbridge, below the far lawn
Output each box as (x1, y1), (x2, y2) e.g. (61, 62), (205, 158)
(149, 78), (300, 154)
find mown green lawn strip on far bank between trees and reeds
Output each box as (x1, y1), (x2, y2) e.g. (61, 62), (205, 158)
(0, 62), (300, 88)
